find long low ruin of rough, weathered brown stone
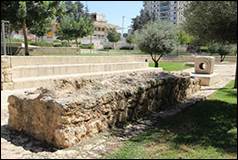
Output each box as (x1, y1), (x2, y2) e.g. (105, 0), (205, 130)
(8, 71), (200, 148)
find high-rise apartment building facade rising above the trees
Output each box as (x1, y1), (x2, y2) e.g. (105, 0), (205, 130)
(143, 1), (188, 24)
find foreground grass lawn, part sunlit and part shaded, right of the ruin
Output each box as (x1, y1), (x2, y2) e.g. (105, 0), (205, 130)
(105, 81), (237, 159)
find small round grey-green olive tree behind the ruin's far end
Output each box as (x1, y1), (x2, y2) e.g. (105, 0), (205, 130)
(135, 21), (177, 67)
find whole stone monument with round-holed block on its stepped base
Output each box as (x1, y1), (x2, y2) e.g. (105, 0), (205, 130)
(192, 56), (218, 86)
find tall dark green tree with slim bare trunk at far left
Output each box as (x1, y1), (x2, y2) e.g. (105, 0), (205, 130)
(1, 1), (59, 55)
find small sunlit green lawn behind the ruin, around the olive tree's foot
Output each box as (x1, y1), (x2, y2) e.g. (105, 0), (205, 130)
(149, 62), (192, 71)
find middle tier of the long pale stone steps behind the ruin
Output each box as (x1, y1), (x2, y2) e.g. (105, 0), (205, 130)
(12, 62), (148, 80)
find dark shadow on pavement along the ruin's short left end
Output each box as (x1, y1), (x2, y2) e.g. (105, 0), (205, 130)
(1, 125), (58, 153)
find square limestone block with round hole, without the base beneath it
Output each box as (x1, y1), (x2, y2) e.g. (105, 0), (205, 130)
(195, 56), (215, 74)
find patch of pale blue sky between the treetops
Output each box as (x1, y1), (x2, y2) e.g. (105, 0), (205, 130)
(81, 1), (143, 33)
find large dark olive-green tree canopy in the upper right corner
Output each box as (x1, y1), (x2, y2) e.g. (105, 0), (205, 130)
(183, 1), (237, 43)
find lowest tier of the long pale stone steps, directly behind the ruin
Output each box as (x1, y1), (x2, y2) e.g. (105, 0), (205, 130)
(13, 67), (162, 89)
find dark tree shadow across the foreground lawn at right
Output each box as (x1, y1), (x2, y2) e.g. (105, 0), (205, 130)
(130, 100), (237, 153)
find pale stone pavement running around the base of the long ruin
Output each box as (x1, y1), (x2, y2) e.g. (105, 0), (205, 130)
(1, 64), (236, 159)
